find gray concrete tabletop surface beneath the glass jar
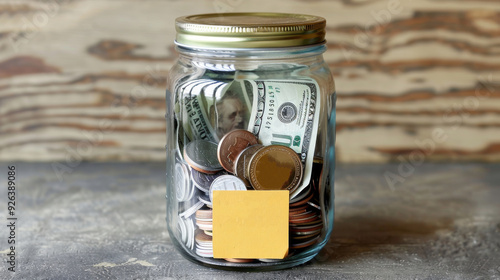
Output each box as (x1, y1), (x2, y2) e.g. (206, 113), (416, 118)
(0, 162), (500, 280)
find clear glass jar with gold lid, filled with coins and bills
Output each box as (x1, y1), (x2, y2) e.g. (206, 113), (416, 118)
(166, 13), (336, 270)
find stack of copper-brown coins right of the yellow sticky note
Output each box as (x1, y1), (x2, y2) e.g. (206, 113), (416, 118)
(289, 186), (323, 249)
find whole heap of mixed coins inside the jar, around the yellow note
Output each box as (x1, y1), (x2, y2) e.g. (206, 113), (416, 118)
(175, 129), (323, 262)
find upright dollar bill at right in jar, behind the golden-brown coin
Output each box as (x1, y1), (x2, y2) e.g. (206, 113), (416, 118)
(244, 79), (321, 198)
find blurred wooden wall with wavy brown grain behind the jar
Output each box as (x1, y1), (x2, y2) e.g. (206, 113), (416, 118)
(0, 0), (500, 164)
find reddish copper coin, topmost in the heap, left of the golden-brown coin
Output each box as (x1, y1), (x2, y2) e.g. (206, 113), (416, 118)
(217, 129), (258, 173)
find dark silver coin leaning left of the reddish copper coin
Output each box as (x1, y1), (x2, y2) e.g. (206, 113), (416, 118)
(184, 140), (222, 174)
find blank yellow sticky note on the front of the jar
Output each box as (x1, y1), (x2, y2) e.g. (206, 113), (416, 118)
(212, 190), (290, 259)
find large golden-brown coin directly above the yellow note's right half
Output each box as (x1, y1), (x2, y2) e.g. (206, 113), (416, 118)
(248, 145), (303, 193)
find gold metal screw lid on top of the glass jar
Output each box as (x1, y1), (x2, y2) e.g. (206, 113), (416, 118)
(175, 13), (326, 48)
